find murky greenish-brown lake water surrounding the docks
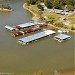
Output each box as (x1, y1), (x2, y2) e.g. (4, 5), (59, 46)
(0, 0), (74, 74)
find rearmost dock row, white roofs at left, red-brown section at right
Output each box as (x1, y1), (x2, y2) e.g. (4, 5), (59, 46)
(5, 21), (47, 31)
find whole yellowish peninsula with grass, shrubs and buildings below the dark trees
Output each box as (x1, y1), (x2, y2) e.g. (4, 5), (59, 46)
(23, 0), (75, 33)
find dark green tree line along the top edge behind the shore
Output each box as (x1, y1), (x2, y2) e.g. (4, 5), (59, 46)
(26, 0), (75, 11)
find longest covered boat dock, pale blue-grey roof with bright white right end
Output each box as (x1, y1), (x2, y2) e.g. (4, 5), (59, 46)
(18, 30), (56, 44)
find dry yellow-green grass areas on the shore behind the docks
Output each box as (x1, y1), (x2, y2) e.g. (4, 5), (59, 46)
(24, 3), (75, 32)
